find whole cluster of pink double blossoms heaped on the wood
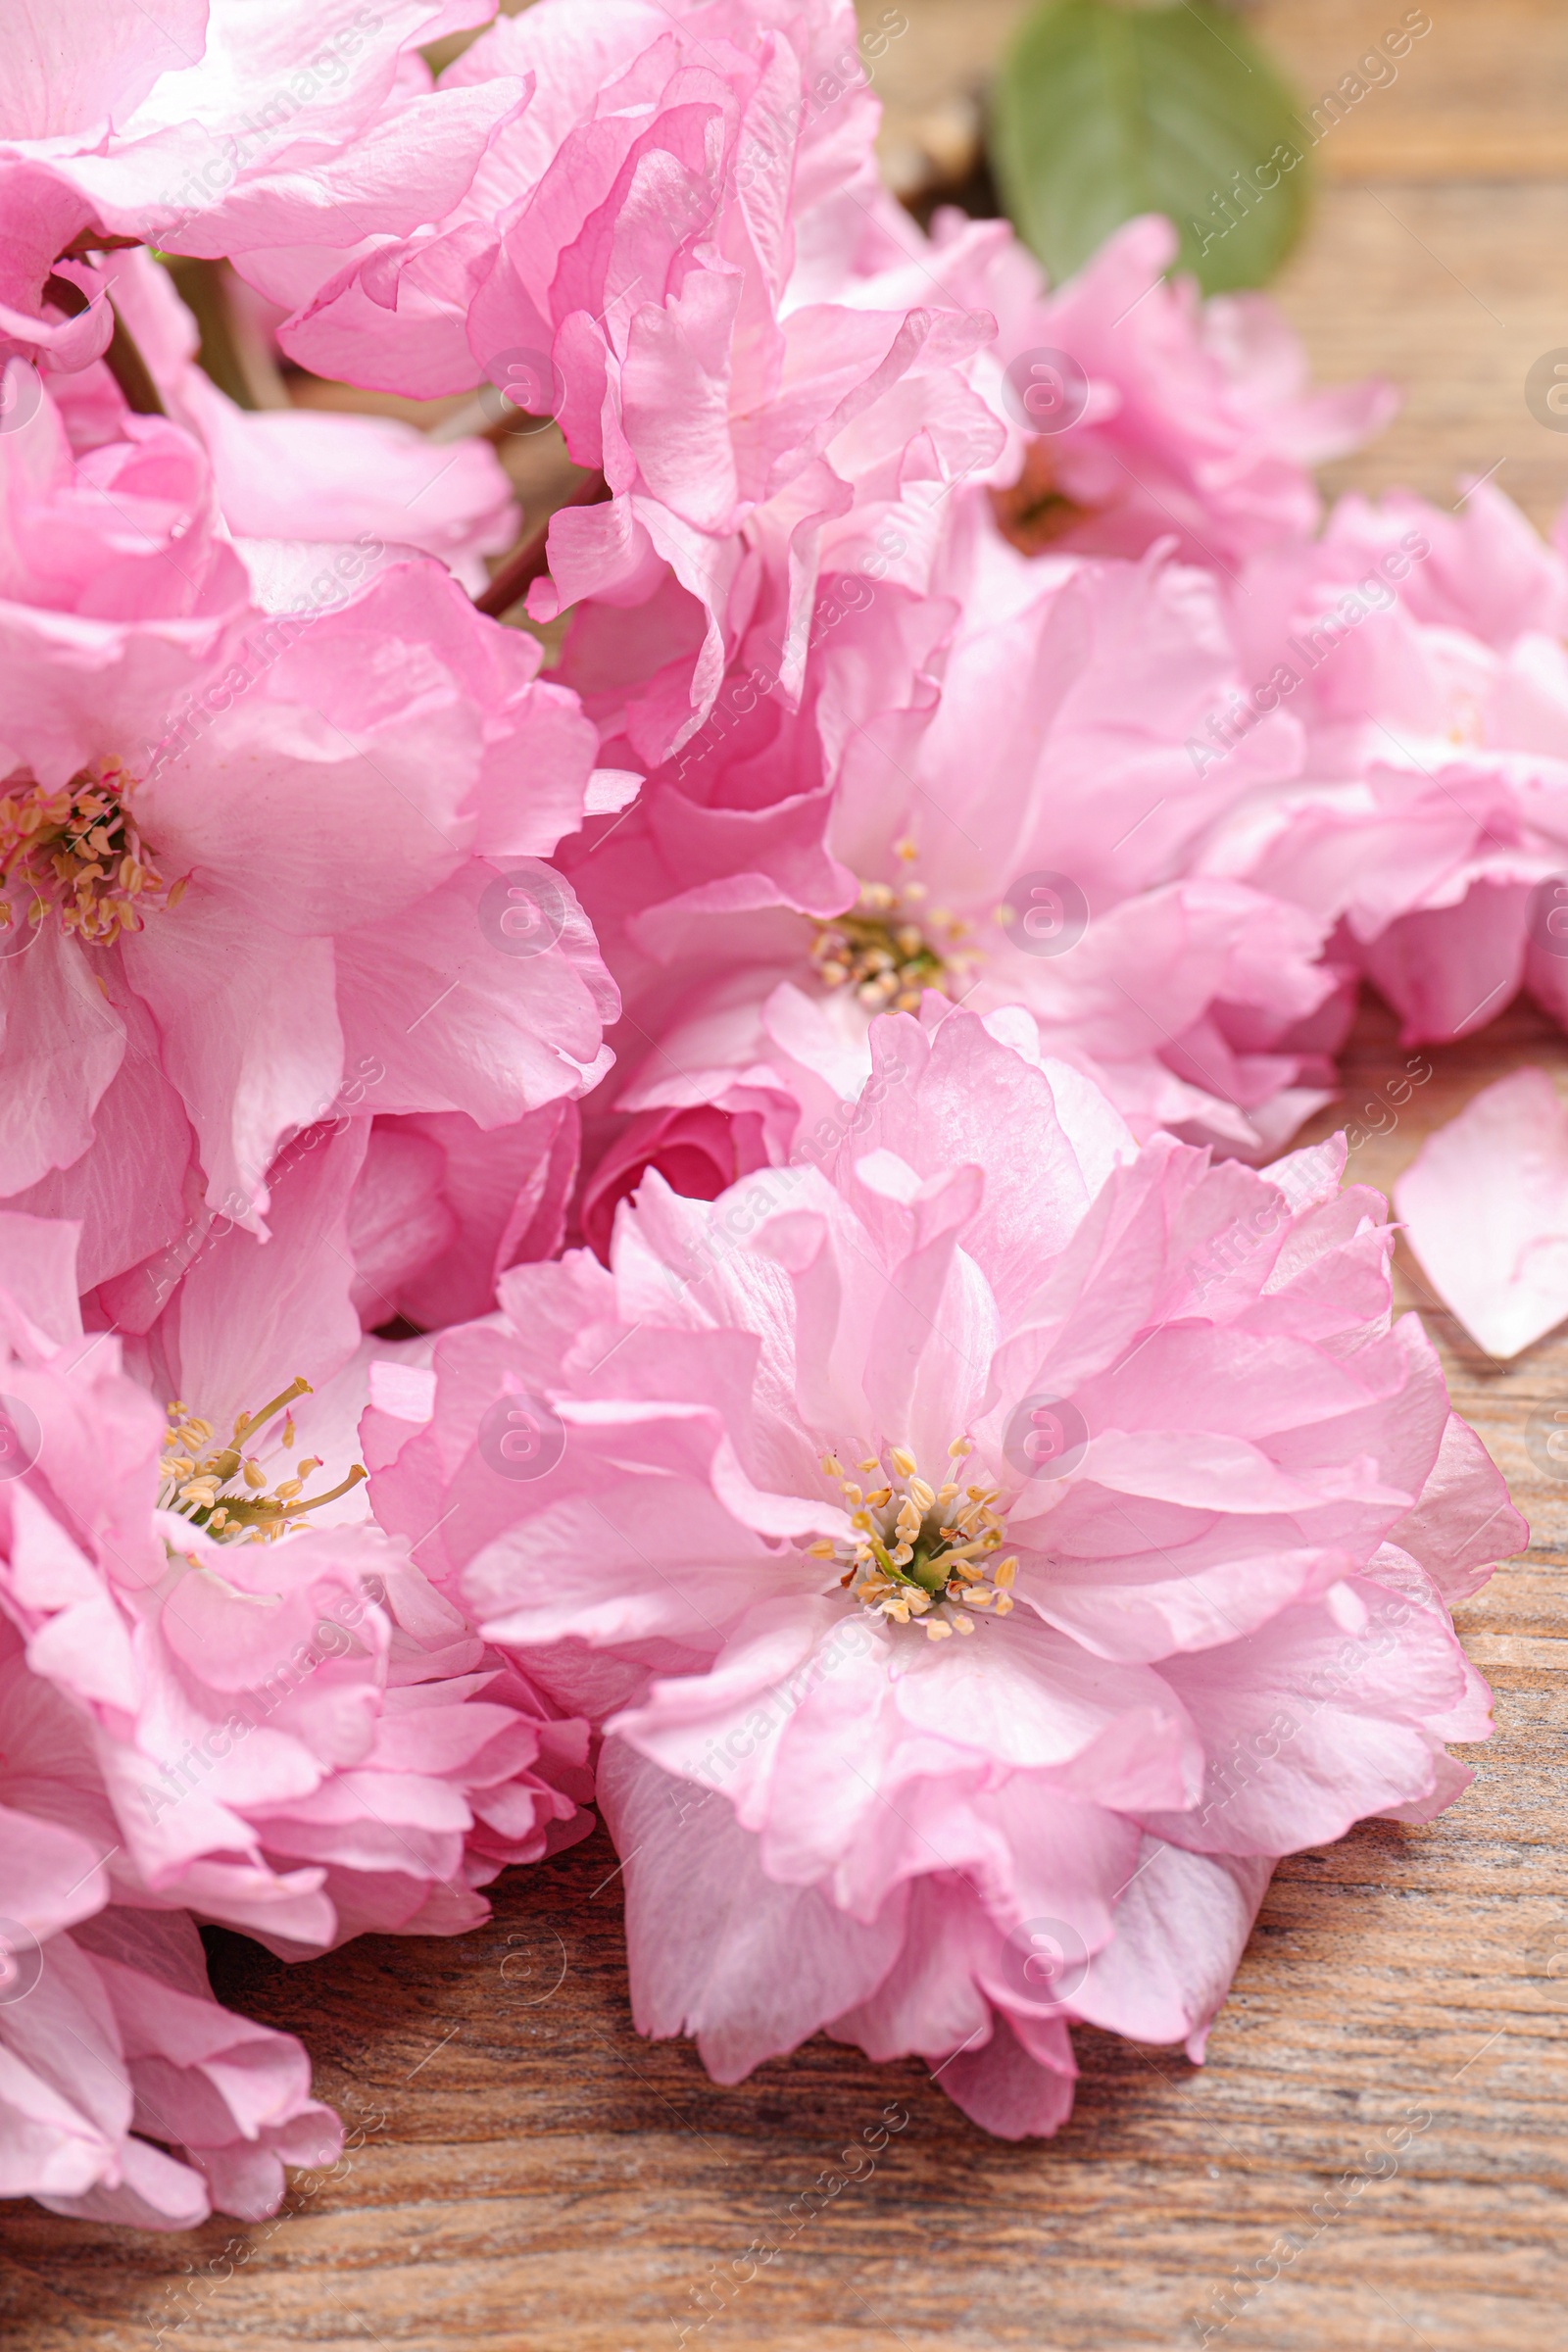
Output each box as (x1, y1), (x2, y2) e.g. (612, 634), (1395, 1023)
(0, 0), (1533, 2228)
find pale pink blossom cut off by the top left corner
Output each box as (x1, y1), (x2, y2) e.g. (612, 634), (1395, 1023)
(0, 0), (524, 348)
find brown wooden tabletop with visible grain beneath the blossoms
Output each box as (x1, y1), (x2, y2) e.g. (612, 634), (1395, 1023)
(12, 0), (1568, 2352)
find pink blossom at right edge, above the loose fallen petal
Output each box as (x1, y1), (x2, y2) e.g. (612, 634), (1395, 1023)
(1192, 484), (1568, 1045)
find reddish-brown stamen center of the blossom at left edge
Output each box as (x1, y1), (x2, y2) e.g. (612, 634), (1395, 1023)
(0, 760), (186, 948)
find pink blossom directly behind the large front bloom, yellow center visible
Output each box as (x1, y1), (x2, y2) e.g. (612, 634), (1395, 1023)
(566, 492), (1348, 1253)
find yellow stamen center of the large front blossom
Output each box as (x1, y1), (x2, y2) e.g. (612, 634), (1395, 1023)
(807, 1437), (1018, 1642)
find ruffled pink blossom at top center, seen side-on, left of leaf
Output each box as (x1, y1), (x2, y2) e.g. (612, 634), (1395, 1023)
(244, 0), (1004, 760)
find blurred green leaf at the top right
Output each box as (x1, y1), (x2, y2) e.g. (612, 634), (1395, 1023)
(992, 0), (1314, 294)
